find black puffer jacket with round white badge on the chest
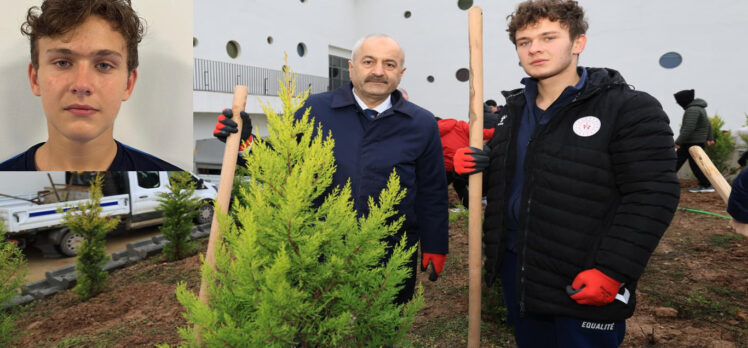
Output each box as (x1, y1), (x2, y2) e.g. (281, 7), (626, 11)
(483, 68), (680, 321)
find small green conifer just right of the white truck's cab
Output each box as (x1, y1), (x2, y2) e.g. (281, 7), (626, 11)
(156, 172), (201, 261)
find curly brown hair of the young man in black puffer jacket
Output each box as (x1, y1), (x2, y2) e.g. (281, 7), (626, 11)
(506, 0), (588, 45)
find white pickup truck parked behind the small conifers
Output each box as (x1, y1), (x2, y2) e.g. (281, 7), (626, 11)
(0, 171), (216, 257)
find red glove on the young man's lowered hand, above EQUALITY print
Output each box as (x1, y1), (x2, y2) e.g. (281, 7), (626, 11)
(571, 268), (621, 306)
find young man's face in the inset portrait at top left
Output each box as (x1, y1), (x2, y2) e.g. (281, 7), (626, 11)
(29, 16), (137, 143)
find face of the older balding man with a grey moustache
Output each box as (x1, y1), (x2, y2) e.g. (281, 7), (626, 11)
(348, 37), (405, 104)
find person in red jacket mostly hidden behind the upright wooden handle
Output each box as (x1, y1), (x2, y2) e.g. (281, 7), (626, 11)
(437, 118), (494, 208)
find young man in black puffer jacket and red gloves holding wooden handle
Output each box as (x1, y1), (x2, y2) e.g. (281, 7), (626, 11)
(455, 0), (679, 347)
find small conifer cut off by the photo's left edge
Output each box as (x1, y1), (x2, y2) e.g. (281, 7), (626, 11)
(0, 220), (26, 347)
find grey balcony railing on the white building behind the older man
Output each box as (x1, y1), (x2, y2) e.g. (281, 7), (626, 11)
(192, 58), (329, 96)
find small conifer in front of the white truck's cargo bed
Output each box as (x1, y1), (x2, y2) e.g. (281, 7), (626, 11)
(63, 173), (119, 301)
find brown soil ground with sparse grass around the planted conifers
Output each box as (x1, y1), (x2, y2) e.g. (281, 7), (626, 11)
(7, 182), (748, 347)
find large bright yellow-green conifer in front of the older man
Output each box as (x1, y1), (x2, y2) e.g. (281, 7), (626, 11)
(172, 61), (423, 347)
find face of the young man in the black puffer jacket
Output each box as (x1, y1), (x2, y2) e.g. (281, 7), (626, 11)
(516, 18), (587, 80)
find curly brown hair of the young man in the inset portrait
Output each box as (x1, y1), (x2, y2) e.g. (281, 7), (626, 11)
(21, 0), (145, 71)
